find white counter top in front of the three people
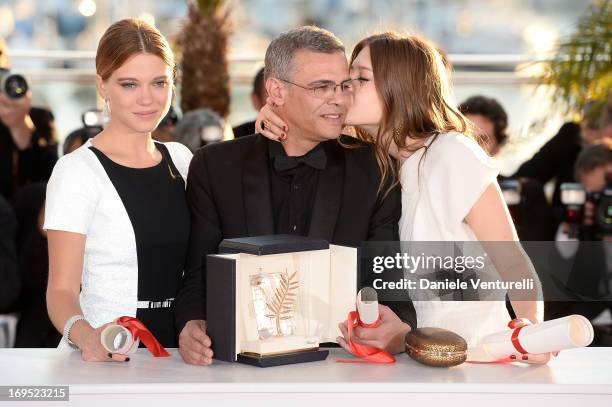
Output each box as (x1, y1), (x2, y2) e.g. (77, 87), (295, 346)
(0, 348), (612, 407)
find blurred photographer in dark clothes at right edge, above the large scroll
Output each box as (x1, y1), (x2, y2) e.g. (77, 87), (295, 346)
(545, 141), (612, 334)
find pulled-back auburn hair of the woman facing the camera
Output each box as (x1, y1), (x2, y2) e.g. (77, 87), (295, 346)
(96, 18), (176, 81)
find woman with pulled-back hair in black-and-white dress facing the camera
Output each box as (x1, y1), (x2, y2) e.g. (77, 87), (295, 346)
(44, 19), (206, 361)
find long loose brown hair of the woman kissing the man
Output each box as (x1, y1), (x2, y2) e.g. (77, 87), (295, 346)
(350, 32), (471, 194)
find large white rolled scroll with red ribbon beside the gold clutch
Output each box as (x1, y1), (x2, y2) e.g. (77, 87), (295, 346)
(480, 315), (593, 359)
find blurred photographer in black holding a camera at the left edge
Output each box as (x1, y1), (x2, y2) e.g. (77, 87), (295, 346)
(0, 38), (58, 200)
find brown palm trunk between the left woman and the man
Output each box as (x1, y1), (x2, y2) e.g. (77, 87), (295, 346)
(178, 0), (233, 118)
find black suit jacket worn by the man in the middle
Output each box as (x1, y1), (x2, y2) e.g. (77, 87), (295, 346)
(174, 134), (416, 332)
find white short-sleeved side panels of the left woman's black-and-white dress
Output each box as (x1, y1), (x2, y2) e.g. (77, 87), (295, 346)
(44, 140), (192, 347)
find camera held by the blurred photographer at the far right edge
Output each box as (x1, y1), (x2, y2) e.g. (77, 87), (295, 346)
(561, 174), (612, 240)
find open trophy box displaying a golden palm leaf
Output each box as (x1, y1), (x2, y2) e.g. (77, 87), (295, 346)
(206, 235), (359, 367)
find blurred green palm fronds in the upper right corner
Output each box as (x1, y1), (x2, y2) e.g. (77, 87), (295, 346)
(541, 0), (612, 113)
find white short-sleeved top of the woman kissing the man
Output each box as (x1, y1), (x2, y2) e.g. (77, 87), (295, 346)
(399, 132), (510, 347)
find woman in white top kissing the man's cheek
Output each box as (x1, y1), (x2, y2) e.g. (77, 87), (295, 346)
(258, 33), (548, 361)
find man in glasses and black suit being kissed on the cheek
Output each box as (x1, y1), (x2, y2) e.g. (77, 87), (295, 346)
(174, 27), (416, 365)
